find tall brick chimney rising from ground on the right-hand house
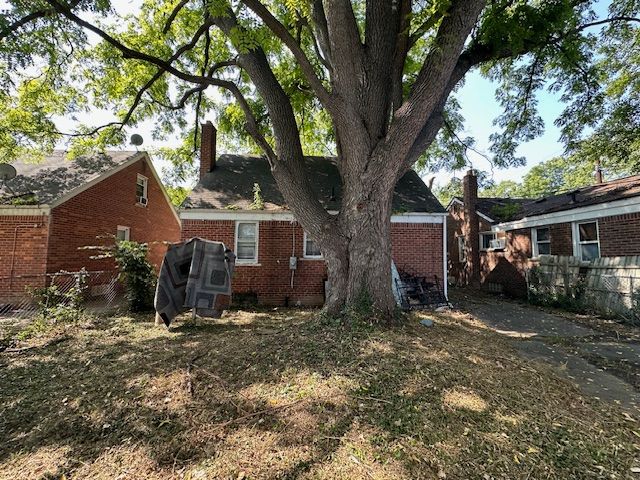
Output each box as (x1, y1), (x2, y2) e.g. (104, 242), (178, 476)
(462, 170), (480, 286)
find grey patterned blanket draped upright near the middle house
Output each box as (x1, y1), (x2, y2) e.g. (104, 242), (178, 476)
(154, 238), (235, 326)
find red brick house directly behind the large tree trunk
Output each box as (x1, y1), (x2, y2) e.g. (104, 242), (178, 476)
(180, 123), (446, 305)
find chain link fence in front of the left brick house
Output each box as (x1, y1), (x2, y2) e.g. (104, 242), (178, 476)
(0, 269), (123, 321)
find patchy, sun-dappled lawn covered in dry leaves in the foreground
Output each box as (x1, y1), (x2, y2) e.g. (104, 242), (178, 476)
(0, 310), (640, 479)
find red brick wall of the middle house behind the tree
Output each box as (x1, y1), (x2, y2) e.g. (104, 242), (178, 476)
(182, 220), (442, 305)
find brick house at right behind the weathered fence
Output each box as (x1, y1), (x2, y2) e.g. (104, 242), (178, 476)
(447, 171), (640, 296)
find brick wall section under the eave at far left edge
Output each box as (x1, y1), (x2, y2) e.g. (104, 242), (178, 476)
(0, 215), (49, 304)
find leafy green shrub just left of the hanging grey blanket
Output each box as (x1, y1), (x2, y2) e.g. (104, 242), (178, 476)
(113, 240), (156, 312)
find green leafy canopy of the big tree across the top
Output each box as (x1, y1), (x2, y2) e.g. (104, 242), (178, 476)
(0, 0), (640, 176)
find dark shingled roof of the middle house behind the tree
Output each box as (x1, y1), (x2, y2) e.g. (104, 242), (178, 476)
(181, 154), (445, 213)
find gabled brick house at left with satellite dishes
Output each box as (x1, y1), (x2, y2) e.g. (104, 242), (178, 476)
(0, 151), (180, 303)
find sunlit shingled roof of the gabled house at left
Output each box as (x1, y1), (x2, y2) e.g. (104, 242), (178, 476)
(0, 150), (142, 205)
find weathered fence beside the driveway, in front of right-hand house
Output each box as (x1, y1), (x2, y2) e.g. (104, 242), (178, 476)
(526, 268), (640, 325)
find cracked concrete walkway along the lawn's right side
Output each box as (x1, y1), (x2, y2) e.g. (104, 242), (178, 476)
(454, 296), (640, 414)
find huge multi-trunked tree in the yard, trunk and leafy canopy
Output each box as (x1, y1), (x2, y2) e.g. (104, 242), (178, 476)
(0, 0), (640, 318)
